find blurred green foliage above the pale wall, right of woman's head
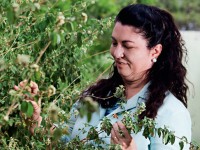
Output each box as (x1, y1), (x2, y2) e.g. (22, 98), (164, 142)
(137, 0), (200, 30)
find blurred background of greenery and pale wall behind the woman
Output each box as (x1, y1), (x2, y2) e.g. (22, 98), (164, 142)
(85, 0), (200, 143)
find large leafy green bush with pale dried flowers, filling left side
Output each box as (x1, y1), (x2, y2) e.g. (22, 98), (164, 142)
(0, 0), (112, 149)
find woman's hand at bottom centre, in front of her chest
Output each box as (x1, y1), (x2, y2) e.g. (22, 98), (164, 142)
(111, 122), (137, 150)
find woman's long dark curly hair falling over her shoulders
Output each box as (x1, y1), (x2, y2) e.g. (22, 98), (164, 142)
(82, 4), (188, 118)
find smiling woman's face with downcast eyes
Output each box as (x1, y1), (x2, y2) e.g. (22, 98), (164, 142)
(110, 22), (154, 81)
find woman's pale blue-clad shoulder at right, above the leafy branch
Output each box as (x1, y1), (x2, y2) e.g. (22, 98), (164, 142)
(155, 92), (192, 149)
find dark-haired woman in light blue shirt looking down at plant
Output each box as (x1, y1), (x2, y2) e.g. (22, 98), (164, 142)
(19, 4), (191, 150)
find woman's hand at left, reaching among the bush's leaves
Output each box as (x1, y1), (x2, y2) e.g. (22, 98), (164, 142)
(14, 80), (42, 134)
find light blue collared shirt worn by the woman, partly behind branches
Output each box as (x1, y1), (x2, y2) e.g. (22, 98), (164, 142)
(62, 84), (191, 150)
